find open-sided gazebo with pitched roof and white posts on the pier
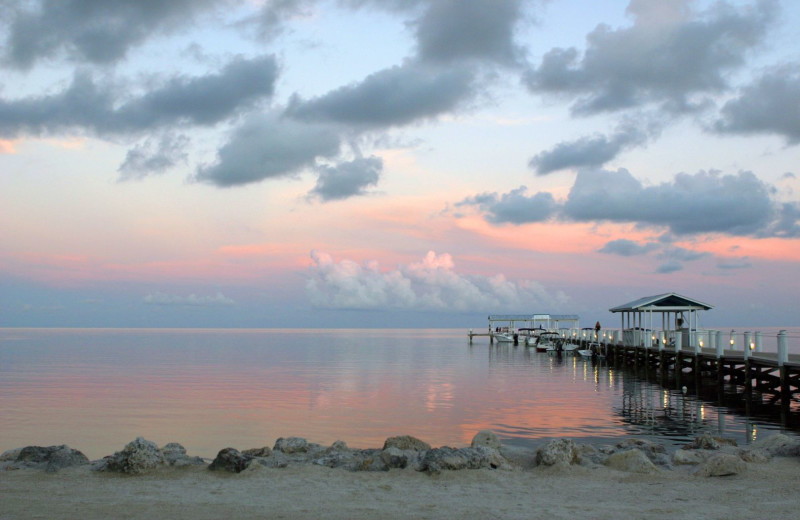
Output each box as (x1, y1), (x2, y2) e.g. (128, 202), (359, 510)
(609, 293), (713, 346)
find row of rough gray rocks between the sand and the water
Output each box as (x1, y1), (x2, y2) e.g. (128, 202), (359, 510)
(6, 431), (800, 477)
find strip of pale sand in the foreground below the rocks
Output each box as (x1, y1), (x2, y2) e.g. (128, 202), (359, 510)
(0, 457), (800, 520)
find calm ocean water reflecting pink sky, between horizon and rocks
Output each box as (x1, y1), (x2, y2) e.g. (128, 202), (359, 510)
(0, 328), (800, 459)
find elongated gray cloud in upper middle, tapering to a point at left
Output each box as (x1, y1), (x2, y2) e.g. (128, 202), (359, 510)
(287, 62), (474, 127)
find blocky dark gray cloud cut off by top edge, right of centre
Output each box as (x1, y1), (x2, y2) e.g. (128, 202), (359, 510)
(414, 0), (521, 64)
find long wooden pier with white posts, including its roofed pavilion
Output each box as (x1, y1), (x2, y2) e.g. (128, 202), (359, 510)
(469, 293), (800, 411)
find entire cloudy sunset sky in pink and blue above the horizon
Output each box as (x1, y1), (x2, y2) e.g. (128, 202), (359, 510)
(0, 0), (800, 329)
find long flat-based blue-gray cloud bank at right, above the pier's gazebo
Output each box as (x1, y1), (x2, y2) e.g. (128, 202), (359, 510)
(466, 168), (800, 238)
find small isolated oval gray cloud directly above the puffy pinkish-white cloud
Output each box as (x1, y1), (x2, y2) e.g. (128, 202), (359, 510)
(310, 156), (383, 201)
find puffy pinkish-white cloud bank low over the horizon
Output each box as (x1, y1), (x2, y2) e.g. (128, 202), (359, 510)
(306, 251), (567, 312)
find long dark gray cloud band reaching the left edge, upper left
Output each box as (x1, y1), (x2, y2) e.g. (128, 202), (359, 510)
(0, 56), (278, 137)
